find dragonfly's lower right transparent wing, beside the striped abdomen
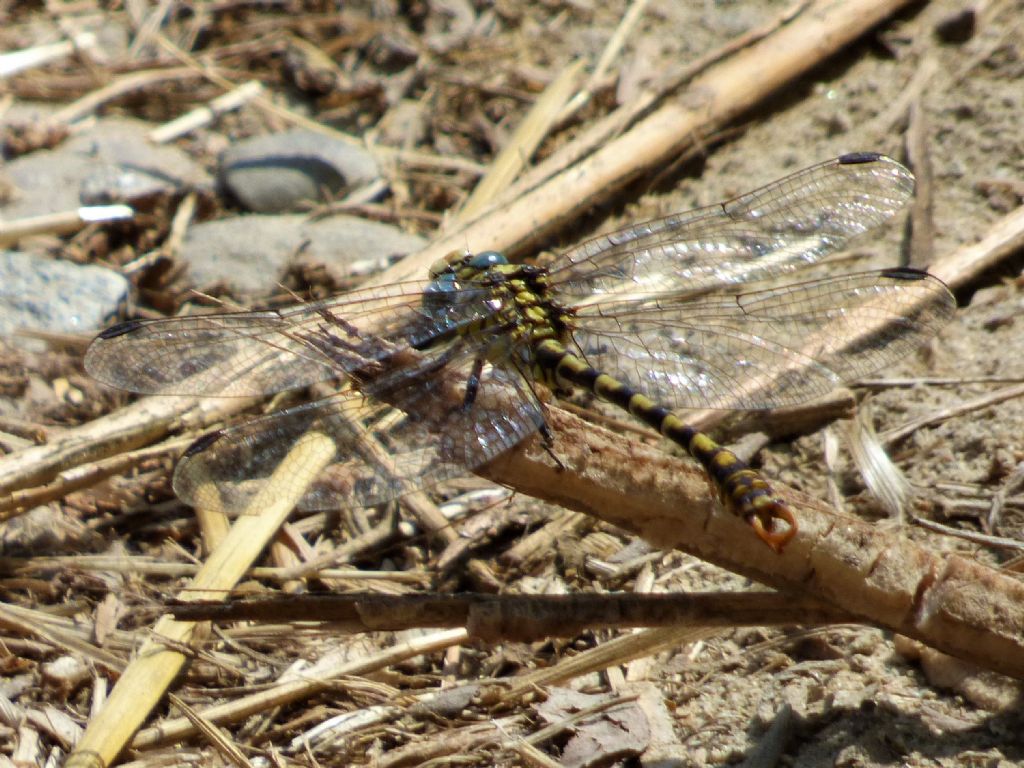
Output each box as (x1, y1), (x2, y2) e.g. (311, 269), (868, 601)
(572, 269), (955, 409)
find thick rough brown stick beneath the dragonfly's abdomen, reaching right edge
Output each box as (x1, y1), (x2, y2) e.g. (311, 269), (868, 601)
(480, 408), (1024, 677)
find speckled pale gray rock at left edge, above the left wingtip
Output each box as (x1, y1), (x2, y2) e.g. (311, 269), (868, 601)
(0, 251), (128, 336)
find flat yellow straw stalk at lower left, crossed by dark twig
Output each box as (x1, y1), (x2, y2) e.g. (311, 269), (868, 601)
(67, 432), (335, 768)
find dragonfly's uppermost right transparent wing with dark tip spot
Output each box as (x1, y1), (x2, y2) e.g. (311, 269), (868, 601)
(551, 153), (913, 304)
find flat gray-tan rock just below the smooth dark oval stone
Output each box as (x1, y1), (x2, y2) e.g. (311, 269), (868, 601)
(180, 214), (426, 296)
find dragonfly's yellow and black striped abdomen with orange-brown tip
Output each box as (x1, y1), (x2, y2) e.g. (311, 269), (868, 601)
(535, 339), (797, 550)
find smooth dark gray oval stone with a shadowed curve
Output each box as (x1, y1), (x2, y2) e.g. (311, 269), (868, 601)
(217, 130), (378, 213)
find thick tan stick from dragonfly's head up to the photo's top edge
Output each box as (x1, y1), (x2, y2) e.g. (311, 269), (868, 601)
(373, 0), (907, 285)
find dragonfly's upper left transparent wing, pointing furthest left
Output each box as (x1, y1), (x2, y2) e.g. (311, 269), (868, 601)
(85, 281), (503, 396)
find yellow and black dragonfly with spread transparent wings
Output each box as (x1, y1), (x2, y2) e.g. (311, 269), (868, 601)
(85, 153), (955, 550)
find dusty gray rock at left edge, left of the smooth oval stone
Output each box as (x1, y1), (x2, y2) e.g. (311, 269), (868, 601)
(0, 118), (210, 219)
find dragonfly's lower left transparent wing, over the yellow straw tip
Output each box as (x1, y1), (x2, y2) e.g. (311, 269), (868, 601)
(174, 361), (543, 514)
